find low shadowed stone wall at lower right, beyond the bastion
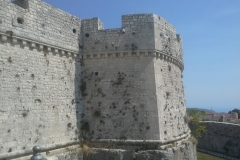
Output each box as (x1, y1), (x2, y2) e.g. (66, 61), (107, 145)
(198, 121), (240, 159)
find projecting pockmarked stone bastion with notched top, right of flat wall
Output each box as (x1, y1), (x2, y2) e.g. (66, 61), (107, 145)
(80, 14), (194, 159)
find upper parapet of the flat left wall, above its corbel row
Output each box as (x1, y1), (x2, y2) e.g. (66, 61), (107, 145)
(0, 0), (81, 52)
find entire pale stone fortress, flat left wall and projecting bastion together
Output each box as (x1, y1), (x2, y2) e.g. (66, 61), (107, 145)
(0, 0), (196, 159)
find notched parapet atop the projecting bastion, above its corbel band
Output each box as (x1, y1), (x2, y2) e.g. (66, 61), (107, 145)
(80, 14), (183, 65)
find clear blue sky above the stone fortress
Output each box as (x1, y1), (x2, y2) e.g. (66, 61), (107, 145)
(44, 0), (240, 112)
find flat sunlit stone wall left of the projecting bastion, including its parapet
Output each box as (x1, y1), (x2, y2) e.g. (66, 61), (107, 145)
(0, 0), (82, 159)
